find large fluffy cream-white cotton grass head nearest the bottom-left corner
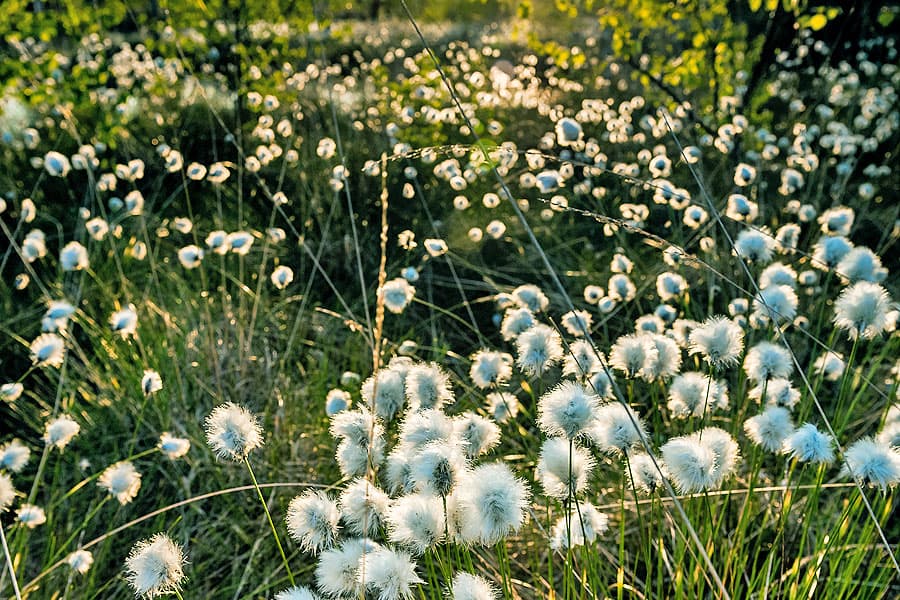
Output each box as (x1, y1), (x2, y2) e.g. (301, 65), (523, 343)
(125, 533), (185, 598)
